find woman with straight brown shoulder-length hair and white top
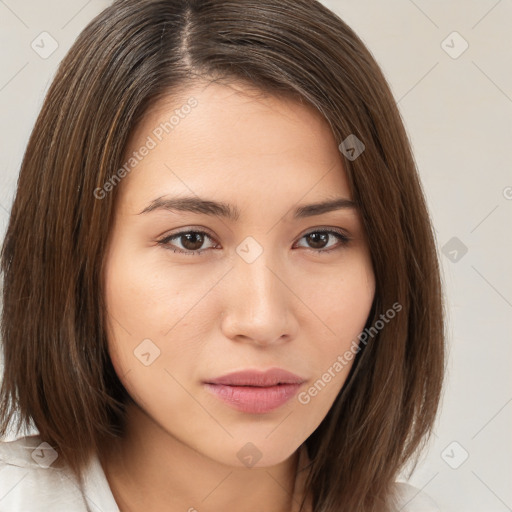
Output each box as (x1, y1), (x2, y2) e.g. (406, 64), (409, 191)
(0, 0), (444, 512)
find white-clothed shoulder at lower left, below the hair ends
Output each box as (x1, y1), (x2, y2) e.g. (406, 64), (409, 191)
(0, 435), (87, 512)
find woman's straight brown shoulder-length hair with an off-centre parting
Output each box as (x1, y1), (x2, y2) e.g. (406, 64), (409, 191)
(0, 0), (445, 512)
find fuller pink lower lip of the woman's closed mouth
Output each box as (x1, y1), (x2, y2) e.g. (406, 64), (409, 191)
(205, 383), (301, 414)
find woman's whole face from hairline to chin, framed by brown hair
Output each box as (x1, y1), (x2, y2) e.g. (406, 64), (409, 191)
(104, 80), (375, 467)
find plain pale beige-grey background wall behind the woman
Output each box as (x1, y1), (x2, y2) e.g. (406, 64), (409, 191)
(0, 0), (512, 512)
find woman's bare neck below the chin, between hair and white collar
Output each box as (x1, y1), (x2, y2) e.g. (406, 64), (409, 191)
(100, 406), (307, 512)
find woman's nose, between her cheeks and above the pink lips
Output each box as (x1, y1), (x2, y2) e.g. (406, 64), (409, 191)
(221, 251), (299, 346)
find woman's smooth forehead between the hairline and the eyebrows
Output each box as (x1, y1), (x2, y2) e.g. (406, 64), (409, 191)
(116, 83), (350, 209)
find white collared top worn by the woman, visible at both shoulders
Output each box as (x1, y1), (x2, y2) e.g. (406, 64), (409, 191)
(0, 435), (440, 512)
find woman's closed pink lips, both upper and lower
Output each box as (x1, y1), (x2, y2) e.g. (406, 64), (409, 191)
(204, 368), (305, 414)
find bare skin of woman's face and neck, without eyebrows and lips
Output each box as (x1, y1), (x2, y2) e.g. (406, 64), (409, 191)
(101, 84), (375, 512)
